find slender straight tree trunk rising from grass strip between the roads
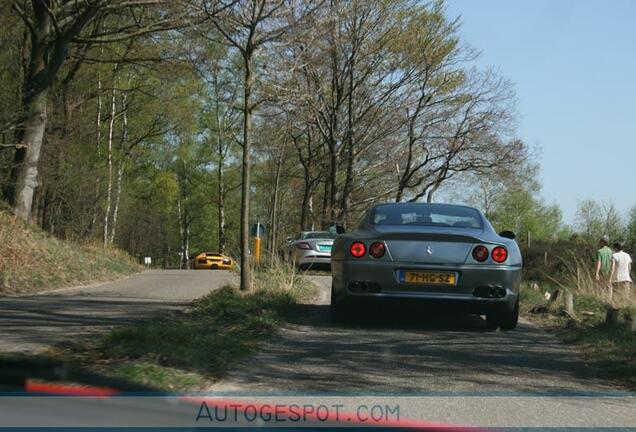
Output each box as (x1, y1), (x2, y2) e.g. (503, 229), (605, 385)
(241, 53), (253, 291)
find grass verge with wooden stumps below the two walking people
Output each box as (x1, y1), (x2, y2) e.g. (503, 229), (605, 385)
(521, 284), (636, 390)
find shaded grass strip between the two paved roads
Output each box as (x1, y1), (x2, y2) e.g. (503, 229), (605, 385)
(53, 269), (310, 390)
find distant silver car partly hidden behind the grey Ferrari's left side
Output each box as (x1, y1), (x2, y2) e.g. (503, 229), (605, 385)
(283, 231), (337, 270)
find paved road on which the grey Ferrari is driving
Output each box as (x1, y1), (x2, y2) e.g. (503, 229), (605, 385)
(210, 276), (636, 426)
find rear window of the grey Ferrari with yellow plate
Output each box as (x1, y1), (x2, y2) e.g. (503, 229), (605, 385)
(371, 204), (482, 228)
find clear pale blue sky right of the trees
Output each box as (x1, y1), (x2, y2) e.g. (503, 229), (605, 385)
(447, 0), (636, 223)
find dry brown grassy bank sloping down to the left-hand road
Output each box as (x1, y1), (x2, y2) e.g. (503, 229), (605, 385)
(0, 211), (142, 295)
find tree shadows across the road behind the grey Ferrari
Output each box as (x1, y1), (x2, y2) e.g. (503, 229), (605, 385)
(217, 298), (609, 393)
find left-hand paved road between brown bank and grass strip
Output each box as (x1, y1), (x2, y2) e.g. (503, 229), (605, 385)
(0, 270), (234, 353)
